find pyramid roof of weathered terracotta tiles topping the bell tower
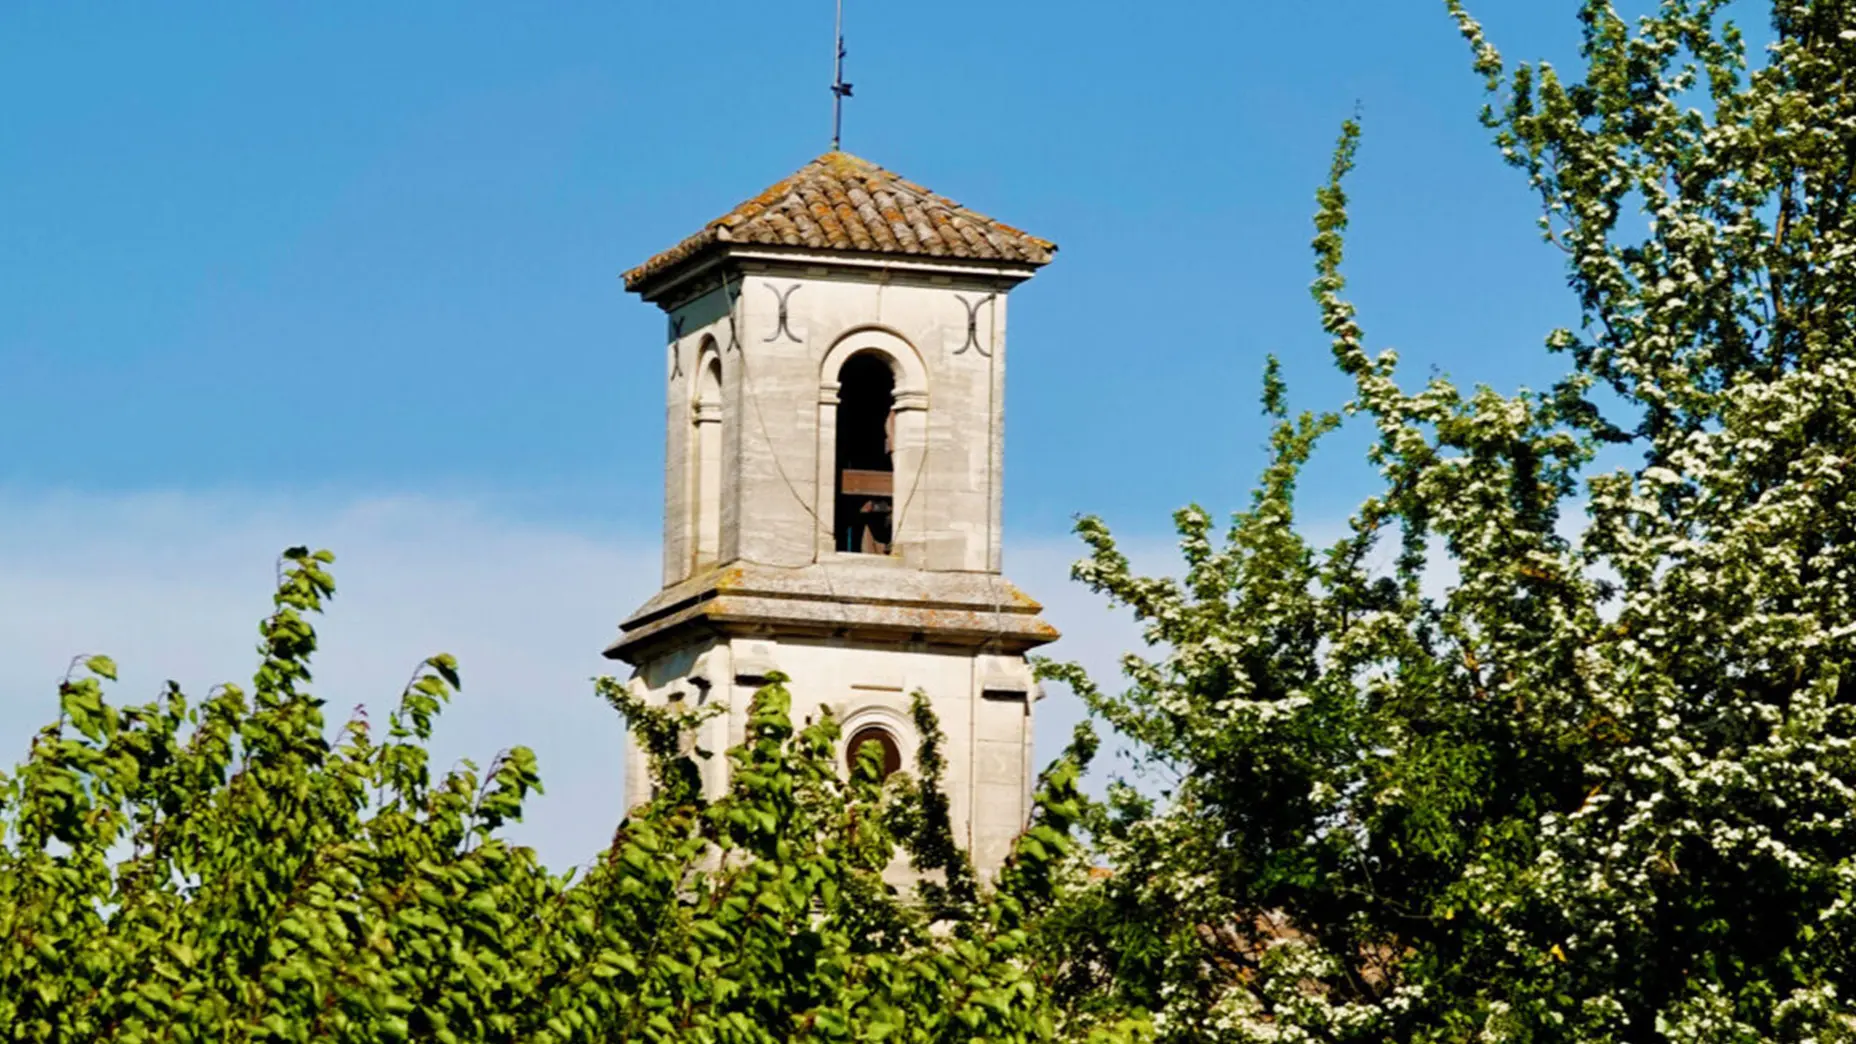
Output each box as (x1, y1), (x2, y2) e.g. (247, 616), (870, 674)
(625, 152), (1056, 290)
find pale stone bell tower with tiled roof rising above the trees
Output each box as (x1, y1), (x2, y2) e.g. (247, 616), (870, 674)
(605, 150), (1056, 871)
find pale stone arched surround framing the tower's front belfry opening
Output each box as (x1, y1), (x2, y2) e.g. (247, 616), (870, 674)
(817, 325), (928, 565)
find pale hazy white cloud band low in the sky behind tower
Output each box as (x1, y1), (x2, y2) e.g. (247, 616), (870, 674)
(0, 492), (1164, 868)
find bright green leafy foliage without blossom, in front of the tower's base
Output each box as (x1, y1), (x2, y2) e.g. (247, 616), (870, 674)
(0, 548), (1128, 1042)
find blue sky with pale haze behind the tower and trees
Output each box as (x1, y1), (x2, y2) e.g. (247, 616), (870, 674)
(0, 0), (1677, 865)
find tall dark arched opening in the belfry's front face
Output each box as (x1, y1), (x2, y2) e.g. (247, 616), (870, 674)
(833, 351), (896, 555)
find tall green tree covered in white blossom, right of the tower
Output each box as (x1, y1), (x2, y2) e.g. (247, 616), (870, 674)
(1045, 0), (1856, 1042)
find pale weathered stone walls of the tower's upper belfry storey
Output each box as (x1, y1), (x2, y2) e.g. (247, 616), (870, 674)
(664, 263), (1006, 585)
